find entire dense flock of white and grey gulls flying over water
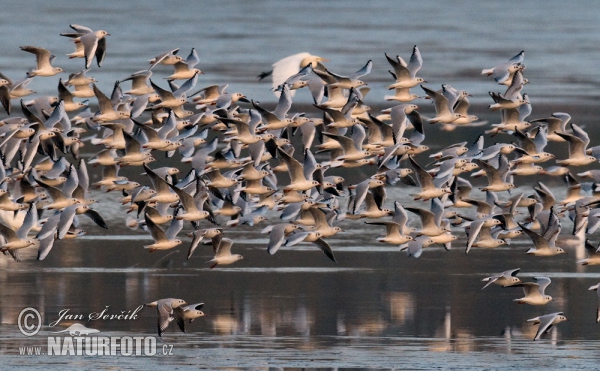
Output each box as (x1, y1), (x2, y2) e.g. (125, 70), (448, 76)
(0, 25), (600, 340)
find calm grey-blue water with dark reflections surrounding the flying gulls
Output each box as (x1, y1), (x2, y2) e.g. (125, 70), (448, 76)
(0, 1), (600, 369)
